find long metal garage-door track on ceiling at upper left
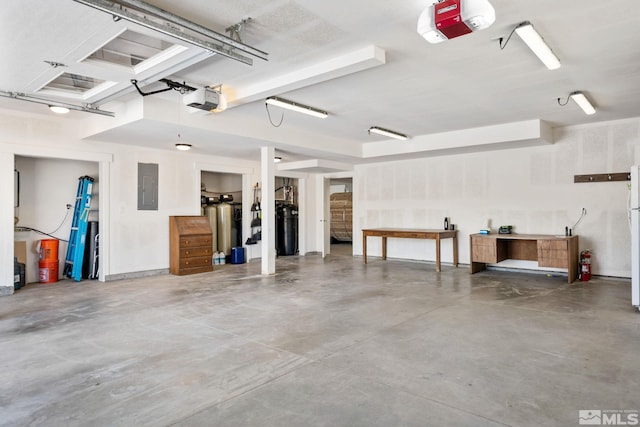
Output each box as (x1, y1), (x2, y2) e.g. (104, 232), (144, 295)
(74, 0), (266, 65)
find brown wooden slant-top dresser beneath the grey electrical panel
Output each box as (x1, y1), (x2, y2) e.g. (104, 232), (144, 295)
(169, 216), (213, 276)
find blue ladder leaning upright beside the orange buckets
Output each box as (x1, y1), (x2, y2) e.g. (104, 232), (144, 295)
(64, 176), (94, 282)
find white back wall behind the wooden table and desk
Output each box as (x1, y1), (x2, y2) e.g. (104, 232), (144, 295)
(354, 119), (640, 277)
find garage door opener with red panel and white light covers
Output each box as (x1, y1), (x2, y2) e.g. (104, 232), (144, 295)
(418, 0), (496, 43)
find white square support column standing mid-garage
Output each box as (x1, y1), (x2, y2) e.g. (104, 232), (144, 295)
(260, 147), (276, 274)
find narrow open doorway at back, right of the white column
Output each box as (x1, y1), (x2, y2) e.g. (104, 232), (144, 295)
(329, 178), (353, 256)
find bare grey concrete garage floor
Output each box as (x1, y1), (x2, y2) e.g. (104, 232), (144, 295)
(0, 251), (640, 427)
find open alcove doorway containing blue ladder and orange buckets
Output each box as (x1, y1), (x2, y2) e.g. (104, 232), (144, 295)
(13, 156), (102, 290)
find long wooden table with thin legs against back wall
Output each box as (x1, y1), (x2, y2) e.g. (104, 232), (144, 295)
(362, 228), (458, 272)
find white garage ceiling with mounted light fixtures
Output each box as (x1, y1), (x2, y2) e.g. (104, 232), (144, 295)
(0, 0), (640, 167)
